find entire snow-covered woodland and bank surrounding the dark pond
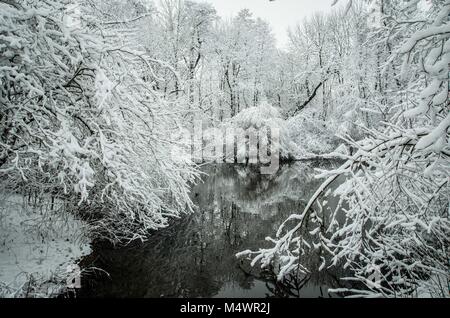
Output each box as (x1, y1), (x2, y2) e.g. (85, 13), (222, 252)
(0, 0), (450, 297)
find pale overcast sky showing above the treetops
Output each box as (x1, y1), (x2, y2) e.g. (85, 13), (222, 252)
(192, 0), (346, 48)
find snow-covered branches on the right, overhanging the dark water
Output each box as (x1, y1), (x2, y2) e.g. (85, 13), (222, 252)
(240, 0), (450, 297)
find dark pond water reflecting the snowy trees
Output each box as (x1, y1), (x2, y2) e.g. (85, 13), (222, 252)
(79, 163), (350, 298)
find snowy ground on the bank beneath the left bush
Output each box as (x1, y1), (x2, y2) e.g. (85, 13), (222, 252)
(0, 193), (91, 297)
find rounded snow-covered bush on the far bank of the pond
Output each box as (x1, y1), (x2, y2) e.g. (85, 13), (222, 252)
(203, 100), (339, 161)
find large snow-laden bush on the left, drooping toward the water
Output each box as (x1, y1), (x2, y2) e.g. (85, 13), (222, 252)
(0, 1), (200, 242)
